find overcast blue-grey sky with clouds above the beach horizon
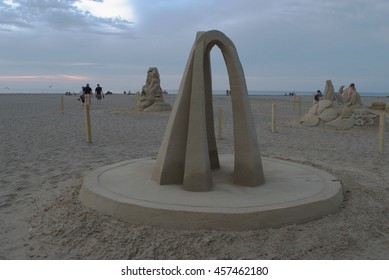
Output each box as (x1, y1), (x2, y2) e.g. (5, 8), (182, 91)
(0, 0), (389, 93)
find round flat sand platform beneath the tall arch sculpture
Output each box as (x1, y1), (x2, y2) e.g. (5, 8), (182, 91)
(80, 155), (343, 230)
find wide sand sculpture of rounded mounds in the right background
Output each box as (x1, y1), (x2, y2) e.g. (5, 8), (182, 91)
(300, 80), (376, 129)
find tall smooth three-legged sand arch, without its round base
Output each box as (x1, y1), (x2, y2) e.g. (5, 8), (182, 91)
(152, 30), (265, 191)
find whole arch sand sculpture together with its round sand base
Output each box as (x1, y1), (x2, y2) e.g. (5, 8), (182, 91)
(80, 31), (343, 230)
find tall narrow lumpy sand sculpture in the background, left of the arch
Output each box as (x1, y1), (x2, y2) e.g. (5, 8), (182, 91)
(137, 67), (172, 112)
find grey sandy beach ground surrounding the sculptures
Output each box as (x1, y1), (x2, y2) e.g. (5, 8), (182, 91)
(0, 94), (389, 259)
